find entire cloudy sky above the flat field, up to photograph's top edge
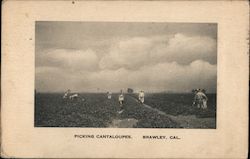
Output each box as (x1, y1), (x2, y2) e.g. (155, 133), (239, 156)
(35, 22), (217, 92)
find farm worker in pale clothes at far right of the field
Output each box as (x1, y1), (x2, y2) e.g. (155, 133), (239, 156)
(193, 89), (208, 109)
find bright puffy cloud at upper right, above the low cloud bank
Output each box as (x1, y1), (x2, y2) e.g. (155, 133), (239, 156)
(150, 34), (217, 64)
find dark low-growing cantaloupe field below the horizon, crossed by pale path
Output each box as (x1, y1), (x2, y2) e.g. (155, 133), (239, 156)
(34, 93), (216, 129)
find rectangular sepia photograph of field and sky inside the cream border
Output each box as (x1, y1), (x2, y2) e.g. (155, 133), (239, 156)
(34, 21), (217, 129)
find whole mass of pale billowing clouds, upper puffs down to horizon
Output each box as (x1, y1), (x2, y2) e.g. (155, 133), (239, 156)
(36, 33), (217, 92)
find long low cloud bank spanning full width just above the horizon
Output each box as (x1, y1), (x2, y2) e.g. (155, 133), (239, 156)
(36, 60), (217, 92)
